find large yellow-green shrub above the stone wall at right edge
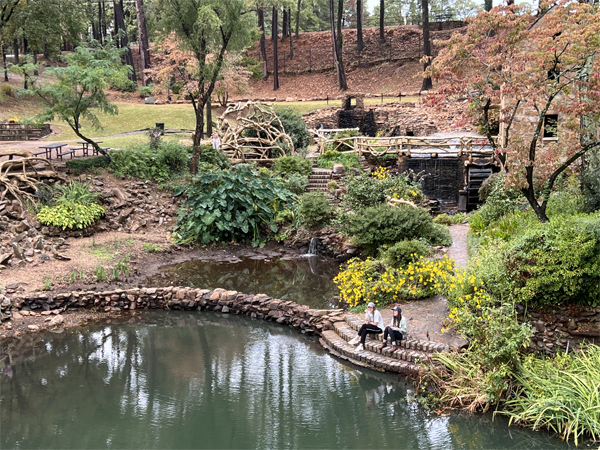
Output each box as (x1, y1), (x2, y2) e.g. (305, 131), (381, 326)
(479, 215), (600, 306)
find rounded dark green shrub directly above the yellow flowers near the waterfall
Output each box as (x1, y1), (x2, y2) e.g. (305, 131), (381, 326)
(341, 204), (442, 253)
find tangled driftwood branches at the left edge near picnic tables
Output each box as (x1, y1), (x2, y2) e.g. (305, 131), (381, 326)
(0, 150), (62, 206)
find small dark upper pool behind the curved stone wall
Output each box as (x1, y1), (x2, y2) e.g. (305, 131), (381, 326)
(144, 256), (339, 308)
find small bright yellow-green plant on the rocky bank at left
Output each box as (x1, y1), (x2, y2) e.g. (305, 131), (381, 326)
(37, 202), (104, 230)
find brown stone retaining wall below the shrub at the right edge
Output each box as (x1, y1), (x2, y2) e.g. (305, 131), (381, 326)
(519, 306), (600, 354)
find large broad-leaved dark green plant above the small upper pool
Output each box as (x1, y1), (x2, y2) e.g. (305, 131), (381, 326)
(174, 164), (294, 245)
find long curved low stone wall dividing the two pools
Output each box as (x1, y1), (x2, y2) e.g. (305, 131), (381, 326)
(11, 287), (344, 335)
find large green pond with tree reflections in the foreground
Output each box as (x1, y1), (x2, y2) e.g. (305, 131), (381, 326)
(0, 311), (567, 449)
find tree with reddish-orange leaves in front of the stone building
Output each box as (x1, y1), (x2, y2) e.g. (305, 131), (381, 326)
(427, 0), (600, 222)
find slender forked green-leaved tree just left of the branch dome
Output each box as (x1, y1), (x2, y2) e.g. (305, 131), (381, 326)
(158, 0), (256, 173)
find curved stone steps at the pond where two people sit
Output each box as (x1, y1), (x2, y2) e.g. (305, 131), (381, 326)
(320, 314), (450, 375)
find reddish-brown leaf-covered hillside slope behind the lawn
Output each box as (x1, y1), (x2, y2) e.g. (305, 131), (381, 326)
(247, 25), (464, 100)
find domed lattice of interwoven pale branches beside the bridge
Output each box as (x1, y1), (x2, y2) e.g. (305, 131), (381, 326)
(217, 101), (294, 161)
